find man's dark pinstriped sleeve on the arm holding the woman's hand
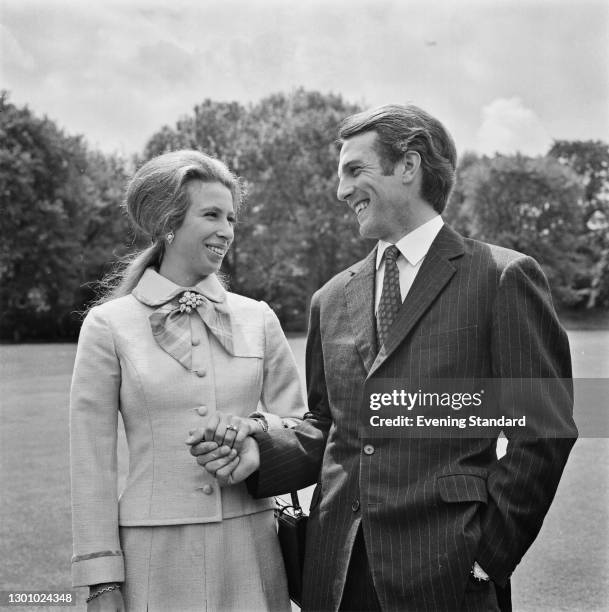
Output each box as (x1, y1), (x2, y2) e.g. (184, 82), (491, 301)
(247, 294), (331, 497)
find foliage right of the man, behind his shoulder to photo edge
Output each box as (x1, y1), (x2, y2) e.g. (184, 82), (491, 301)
(446, 150), (609, 308)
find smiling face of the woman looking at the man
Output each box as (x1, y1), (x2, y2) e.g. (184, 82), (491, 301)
(160, 180), (235, 287)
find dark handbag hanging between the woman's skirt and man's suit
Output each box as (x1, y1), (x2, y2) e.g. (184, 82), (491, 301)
(275, 491), (309, 607)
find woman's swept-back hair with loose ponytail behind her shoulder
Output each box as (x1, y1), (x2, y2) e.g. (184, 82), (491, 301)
(95, 150), (242, 305)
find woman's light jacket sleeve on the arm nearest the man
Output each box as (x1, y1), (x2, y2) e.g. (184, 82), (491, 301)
(254, 304), (306, 429)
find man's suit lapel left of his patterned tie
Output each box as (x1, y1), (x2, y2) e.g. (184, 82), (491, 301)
(345, 249), (376, 371)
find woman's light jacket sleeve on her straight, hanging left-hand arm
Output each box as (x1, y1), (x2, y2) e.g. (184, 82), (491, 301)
(70, 309), (124, 586)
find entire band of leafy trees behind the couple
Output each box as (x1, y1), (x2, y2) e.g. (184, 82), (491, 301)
(0, 89), (609, 340)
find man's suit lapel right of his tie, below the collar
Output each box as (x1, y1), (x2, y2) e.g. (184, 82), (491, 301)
(368, 225), (464, 377)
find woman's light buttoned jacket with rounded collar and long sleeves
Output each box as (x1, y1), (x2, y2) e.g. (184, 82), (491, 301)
(70, 269), (305, 586)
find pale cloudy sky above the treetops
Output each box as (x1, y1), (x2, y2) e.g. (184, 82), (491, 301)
(0, 0), (609, 155)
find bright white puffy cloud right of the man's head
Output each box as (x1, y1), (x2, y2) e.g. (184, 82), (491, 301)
(475, 97), (552, 155)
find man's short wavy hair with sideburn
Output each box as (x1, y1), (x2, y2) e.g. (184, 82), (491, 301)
(338, 104), (457, 213)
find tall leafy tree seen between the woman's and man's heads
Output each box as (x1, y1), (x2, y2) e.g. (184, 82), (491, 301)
(238, 89), (370, 328)
